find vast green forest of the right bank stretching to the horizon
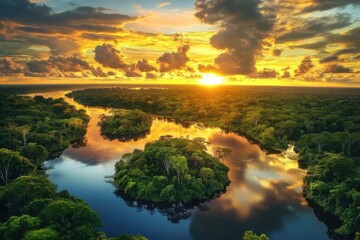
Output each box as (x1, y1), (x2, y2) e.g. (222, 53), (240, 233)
(68, 86), (360, 236)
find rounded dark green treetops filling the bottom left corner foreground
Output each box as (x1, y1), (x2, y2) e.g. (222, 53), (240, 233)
(0, 176), (101, 240)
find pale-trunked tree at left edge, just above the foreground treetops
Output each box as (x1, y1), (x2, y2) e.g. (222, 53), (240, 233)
(0, 148), (35, 184)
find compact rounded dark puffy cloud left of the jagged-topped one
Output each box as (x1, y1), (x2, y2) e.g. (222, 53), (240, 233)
(95, 43), (129, 69)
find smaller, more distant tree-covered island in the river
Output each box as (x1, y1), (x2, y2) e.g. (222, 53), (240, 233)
(100, 109), (152, 141)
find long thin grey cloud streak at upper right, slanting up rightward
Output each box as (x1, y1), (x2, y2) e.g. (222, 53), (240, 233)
(276, 14), (352, 43)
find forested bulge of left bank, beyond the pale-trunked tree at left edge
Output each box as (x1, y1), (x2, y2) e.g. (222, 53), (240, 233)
(0, 94), (89, 167)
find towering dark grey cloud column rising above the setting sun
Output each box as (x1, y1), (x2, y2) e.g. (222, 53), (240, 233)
(195, 0), (275, 74)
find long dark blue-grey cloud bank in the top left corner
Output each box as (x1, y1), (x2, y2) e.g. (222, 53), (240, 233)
(0, 0), (134, 32)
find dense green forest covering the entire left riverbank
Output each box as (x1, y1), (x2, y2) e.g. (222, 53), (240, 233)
(0, 93), (146, 240)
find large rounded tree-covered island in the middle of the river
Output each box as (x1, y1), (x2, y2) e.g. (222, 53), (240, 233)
(114, 139), (229, 202)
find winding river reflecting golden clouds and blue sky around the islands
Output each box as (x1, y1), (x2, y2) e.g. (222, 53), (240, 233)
(26, 92), (329, 240)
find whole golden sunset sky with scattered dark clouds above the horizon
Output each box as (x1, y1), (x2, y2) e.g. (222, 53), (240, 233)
(0, 0), (360, 87)
